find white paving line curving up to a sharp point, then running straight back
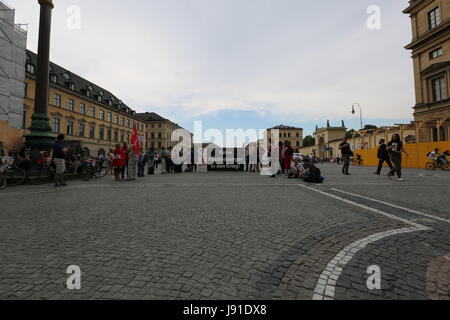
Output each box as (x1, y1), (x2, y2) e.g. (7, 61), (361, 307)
(299, 185), (432, 300)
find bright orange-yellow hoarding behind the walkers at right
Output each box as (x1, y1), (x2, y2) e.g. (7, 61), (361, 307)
(355, 141), (450, 169)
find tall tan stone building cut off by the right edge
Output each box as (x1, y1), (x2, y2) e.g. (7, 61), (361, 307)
(403, 0), (450, 142)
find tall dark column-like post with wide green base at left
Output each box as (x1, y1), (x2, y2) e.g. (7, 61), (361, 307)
(25, 0), (54, 160)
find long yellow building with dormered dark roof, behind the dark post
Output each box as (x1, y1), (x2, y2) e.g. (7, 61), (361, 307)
(23, 51), (146, 156)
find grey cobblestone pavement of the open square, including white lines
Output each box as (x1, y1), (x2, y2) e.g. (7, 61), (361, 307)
(0, 165), (450, 299)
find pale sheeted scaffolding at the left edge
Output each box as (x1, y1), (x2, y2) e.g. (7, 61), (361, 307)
(0, 1), (27, 129)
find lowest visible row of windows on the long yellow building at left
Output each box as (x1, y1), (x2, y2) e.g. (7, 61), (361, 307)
(52, 118), (131, 142)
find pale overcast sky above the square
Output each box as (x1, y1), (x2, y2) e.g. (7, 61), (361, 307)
(7, 0), (414, 138)
